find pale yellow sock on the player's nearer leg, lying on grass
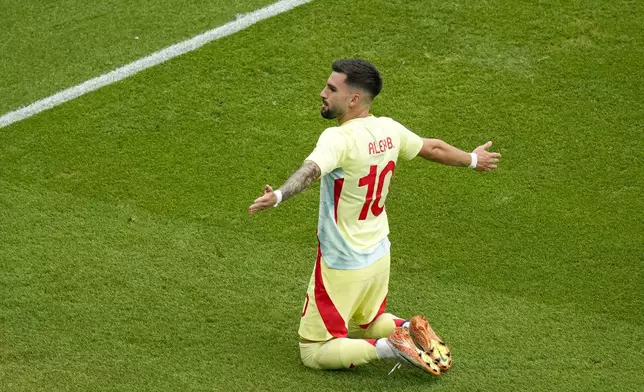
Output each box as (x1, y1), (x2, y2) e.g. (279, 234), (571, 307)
(300, 338), (386, 369)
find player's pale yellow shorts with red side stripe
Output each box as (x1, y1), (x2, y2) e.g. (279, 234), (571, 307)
(298, 246), (390, 342)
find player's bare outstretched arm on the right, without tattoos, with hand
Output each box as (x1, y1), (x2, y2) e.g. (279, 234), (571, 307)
(418, 139), (501, 172)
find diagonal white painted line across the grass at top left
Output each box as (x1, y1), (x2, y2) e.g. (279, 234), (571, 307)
(0, 0), (313, 128)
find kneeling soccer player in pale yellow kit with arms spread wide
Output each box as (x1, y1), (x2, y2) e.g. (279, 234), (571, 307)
(249, 59), (501, 375)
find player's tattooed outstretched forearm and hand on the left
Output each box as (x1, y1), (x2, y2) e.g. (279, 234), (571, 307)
(248, 161), (321, 215)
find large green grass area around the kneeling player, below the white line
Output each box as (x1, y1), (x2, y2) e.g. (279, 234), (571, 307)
(0, 0), (644, 391)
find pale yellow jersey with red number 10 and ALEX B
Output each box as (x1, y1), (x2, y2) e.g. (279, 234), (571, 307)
(306, 116), (423, 269)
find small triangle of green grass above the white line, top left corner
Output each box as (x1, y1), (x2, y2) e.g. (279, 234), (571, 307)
(0, 0), (271, 113)
